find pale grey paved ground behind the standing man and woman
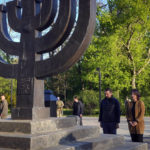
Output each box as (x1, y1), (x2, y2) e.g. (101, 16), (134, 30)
(83, 117), (150, 150)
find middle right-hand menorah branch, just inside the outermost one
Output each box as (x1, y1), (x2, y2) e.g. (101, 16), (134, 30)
(35, 0), (71, 53)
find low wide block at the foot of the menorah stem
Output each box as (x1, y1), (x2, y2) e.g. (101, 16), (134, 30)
(11, 107), (50, 120)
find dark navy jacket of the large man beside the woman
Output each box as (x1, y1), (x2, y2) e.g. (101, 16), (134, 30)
(99, 97), (121, 123)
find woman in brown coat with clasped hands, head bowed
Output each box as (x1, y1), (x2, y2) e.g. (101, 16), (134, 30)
(126, 89), (145, 142)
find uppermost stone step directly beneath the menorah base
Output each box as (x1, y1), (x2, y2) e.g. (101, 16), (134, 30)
(0, 117), (77, 135)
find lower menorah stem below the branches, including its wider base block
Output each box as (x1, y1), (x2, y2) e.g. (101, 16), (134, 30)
(12, 78), (50, 120)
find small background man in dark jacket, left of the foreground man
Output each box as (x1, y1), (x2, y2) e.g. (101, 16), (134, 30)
(73, 96), (83, 126)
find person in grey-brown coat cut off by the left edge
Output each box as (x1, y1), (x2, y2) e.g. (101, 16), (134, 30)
(0, 95), (8, 119)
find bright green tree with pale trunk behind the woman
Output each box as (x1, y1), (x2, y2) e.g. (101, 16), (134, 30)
(111, 0), (150, 88)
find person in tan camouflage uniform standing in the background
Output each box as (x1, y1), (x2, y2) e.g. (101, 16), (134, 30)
(56, 97), (64, 117)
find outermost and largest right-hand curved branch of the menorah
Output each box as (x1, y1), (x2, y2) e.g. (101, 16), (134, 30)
(36, 0), (96, 78)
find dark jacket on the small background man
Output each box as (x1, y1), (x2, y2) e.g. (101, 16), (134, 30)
(73, 101), (83, 116)
